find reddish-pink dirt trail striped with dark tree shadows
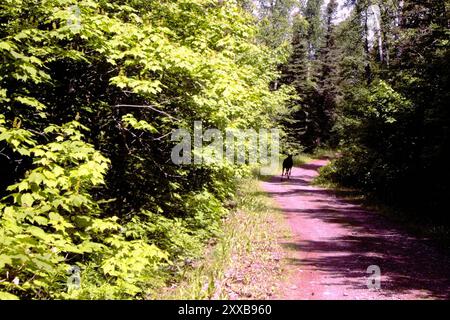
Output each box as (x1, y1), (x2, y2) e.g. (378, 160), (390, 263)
(263, 160), (450, 300)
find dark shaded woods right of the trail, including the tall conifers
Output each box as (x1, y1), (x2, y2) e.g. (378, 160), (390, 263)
(283, 0), (450, 224)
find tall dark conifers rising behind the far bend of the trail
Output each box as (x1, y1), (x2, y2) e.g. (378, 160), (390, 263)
(280, 0), (339, 151)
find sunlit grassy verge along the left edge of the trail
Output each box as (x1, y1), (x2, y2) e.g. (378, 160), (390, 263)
(158, 178), (291, 300)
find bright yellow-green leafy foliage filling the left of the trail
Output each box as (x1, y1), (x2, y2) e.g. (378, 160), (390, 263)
(0, 0), (289, 299)
